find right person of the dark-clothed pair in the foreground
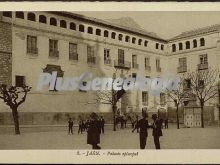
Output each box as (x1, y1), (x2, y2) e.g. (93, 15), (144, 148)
(152, 114), (163, 149)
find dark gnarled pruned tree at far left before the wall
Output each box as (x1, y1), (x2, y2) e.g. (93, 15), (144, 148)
(0, 85), (31, 134)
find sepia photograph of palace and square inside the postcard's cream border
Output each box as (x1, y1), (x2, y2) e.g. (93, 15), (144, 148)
(0, 11), (220, 150)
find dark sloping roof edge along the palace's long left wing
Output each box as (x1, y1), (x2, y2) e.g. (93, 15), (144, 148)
(47, 11), (168, 43)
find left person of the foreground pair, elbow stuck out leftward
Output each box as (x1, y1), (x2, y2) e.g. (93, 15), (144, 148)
(132, 112), (150, 149)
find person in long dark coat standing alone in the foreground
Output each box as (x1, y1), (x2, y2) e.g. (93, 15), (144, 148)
(87, 112), (101, 149)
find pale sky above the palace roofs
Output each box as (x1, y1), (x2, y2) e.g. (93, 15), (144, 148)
(74, 11), (220, 39)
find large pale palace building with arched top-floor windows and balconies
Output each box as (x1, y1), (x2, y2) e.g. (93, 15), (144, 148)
(0, 11), (220, 124)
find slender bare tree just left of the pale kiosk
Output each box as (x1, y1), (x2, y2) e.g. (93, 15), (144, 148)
(166, 78), (187, 129)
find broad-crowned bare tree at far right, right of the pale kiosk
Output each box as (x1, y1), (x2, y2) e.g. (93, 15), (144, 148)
(187, 68), (219, 128)
